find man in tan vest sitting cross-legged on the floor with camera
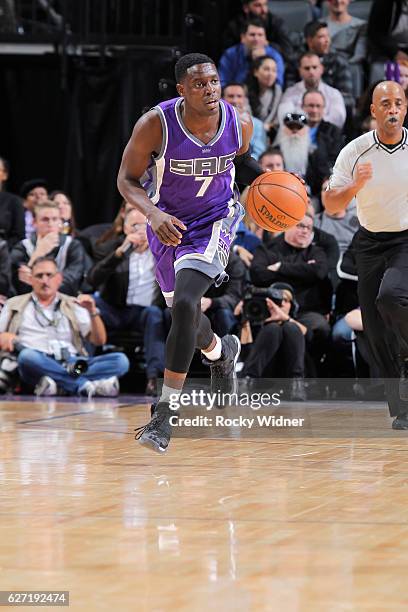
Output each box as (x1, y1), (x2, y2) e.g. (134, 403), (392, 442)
(0, 257), (129, 397)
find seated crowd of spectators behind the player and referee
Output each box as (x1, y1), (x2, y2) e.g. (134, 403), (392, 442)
(0, 0), (408, 400)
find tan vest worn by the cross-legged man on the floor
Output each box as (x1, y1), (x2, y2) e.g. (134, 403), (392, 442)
(5, 293), (87, 355)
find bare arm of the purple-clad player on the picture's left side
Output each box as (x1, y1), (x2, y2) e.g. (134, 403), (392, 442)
(118, 110), (186, 246)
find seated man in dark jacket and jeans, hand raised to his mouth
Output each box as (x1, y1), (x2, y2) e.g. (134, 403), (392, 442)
(87, 207), (166, 395)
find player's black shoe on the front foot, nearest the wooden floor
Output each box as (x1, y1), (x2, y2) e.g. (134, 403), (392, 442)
(135, 402), (177, 453)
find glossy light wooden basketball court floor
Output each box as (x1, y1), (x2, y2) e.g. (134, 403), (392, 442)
(0, 398), (408, 612)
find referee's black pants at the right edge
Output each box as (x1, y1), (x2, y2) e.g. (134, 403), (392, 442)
(353, 228), (408, 416)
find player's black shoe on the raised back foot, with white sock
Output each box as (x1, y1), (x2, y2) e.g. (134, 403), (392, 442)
(203, 335), (241, 393)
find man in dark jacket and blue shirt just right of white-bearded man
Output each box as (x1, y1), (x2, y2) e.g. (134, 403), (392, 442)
(302, 90), (344, 167)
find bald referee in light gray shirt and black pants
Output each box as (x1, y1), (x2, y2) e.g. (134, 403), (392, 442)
(324, 81), (408, 429)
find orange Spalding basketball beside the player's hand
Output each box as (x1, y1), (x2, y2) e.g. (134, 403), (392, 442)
(246, 170), (307, 232)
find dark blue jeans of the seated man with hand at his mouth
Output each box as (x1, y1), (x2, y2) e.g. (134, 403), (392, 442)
(95, 296), (167, 378)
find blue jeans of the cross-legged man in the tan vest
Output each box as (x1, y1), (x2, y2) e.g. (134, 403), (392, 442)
(18, 348), (129, 395)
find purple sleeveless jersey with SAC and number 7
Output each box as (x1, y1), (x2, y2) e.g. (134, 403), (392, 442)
(142, 98), (242, 230)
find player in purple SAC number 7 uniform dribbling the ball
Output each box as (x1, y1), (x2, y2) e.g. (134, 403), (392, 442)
(118, 53), (263, 451)
